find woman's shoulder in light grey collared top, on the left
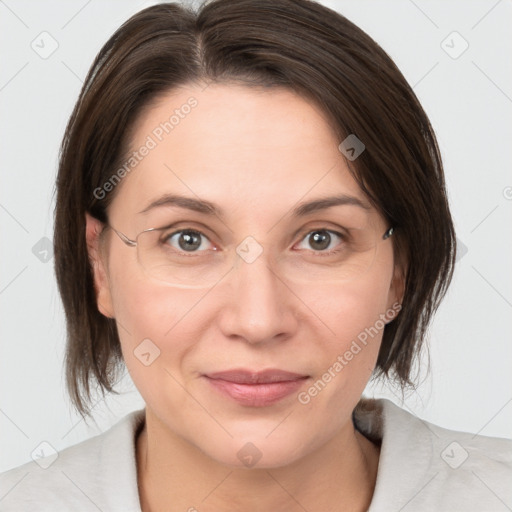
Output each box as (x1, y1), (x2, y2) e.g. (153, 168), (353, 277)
(0, 409), (144, 512)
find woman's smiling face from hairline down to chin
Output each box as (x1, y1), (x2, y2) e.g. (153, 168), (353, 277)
(87, 84), (401, 467)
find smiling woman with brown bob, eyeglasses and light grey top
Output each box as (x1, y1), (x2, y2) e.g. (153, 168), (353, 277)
(0, 0), (512, 511)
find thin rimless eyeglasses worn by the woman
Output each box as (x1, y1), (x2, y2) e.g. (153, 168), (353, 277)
(108, 224), (394, 288)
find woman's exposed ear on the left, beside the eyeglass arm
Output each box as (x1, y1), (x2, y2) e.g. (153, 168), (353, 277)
(85, 212), (114, 318)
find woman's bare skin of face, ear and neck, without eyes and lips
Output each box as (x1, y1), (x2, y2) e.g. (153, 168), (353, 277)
(86, 84), (403, 512)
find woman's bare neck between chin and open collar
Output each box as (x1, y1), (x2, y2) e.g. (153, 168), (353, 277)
(137, 409), (379, 512)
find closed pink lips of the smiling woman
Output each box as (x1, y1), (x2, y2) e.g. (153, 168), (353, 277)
(203, 369), (309, 407)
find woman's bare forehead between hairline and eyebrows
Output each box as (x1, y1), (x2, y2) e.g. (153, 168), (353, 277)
(113, 84), (367, 224)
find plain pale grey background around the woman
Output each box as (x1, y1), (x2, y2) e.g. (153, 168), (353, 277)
(0, 0), (512, 471)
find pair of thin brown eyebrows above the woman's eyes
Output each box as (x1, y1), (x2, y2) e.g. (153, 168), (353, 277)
(139, 194), (371, 218)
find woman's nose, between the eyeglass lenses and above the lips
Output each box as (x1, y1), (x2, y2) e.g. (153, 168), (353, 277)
(218, 247), (300, 344)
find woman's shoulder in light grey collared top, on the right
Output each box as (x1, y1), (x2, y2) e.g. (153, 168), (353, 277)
(355, 400), (512, 512)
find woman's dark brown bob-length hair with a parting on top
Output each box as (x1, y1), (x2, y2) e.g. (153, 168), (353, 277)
(54, 0), (455, 415)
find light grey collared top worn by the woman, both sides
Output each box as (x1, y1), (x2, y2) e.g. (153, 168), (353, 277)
(0, 400), (512, 512)
